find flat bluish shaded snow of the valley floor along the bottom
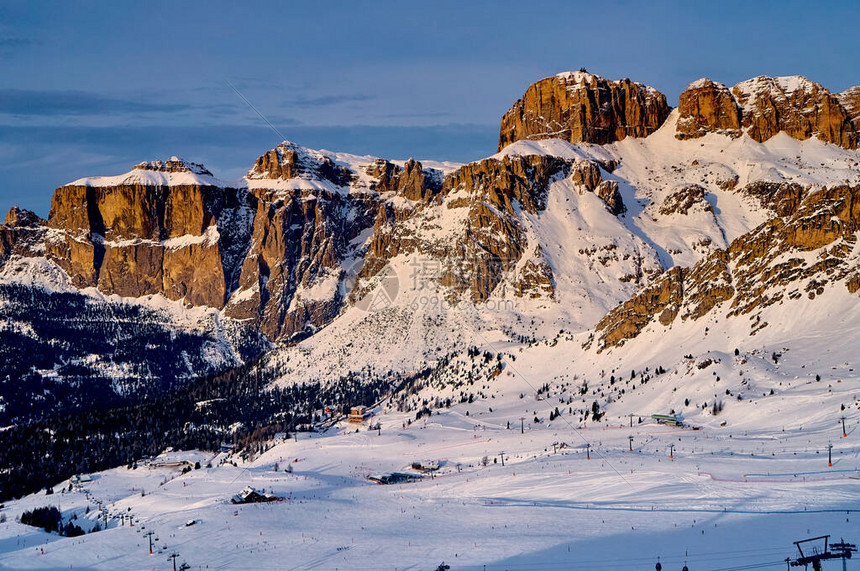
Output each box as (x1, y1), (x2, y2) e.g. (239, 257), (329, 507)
(0, 394), (860, 571)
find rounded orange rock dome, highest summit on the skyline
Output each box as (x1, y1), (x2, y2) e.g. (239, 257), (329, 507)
(499, 72), (669, 150)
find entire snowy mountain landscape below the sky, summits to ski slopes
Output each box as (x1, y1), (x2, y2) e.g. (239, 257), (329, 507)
(0, 71), (860, 571)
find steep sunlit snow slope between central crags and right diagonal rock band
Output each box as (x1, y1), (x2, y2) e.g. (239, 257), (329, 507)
(260, 113), (860, 383)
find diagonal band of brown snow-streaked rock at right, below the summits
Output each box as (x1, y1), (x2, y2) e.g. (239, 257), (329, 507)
(596, 186), (860, 350)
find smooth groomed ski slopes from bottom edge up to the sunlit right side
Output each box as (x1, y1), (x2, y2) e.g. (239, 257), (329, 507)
(0, 286), (860, 571)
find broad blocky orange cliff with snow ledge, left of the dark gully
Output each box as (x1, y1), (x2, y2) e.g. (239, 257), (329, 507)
(45, 158), (253, 308)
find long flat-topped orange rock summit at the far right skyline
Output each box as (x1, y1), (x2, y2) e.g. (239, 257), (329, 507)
(676, 76), (860, 149)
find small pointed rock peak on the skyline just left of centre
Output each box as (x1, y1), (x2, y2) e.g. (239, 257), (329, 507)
(245, 141), (353, 186)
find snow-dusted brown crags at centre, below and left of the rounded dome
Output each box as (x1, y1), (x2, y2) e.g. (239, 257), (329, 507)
(361, 155), (572, 302)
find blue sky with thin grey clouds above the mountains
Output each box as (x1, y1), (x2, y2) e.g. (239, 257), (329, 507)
(0, 0), (860, 216)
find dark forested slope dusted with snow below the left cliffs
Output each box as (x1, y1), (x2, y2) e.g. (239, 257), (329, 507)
(0, 257), (271, 426)
